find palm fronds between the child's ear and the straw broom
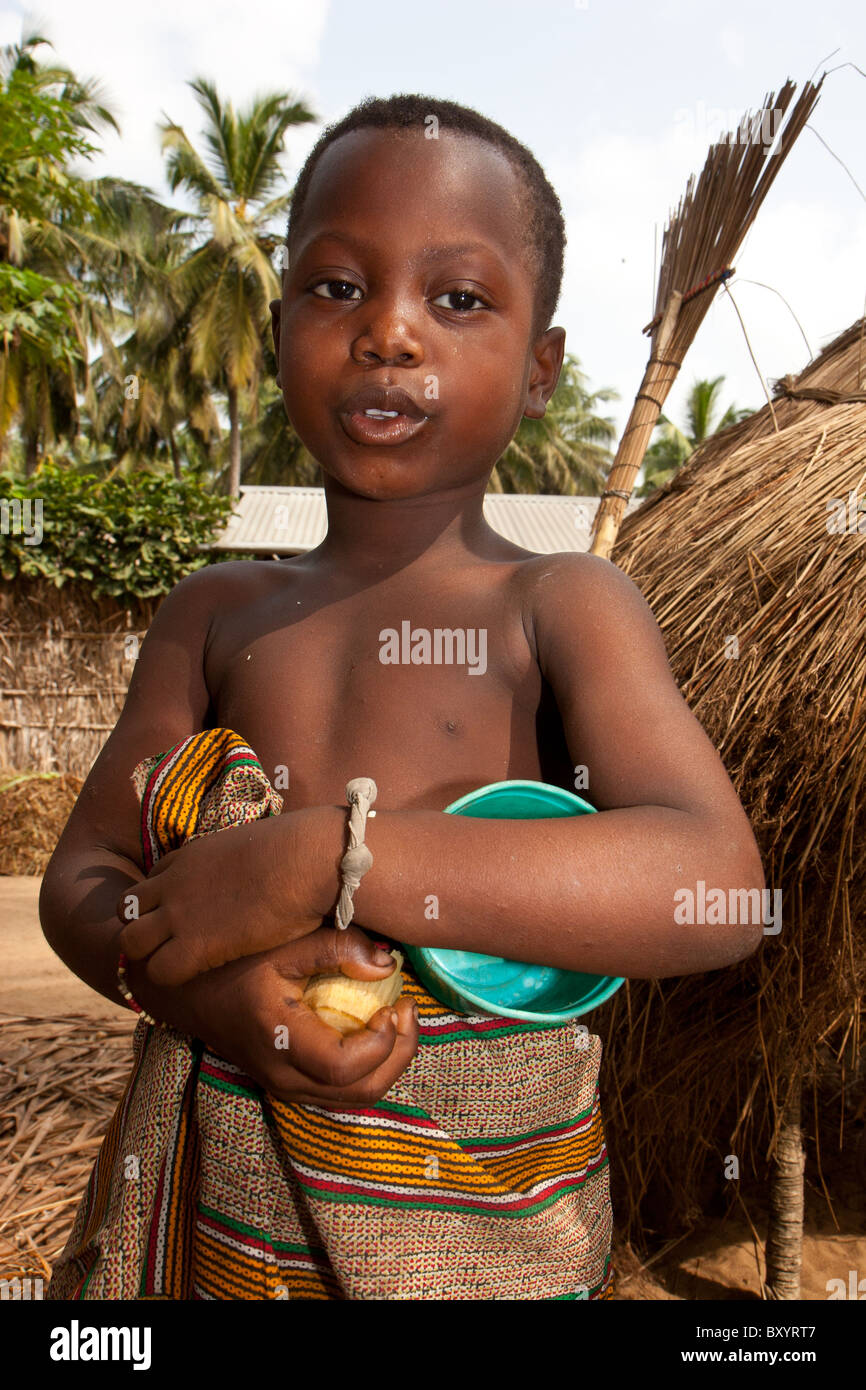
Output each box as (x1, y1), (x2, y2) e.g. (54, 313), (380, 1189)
(488, 353), (619, 496)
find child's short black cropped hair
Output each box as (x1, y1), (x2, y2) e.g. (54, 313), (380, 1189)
(286, 92), (566, 336)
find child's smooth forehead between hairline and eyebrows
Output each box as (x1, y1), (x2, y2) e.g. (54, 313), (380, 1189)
(292, 126), (531, 275)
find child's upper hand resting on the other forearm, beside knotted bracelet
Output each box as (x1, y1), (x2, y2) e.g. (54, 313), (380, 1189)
(117, 812), (338, 986)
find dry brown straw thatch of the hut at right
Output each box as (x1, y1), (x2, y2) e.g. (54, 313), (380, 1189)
(606, 320), (866, 1243)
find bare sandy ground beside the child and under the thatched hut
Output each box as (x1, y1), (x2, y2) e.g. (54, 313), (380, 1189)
(0, 877), (866, 1301)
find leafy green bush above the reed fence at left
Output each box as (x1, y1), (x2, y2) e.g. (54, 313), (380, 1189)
(0, 459), (232, 598)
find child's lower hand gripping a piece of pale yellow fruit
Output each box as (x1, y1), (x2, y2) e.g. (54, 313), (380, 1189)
(131, 924), (418, 1105)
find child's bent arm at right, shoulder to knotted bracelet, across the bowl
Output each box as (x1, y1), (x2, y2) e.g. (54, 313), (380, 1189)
(335, 556), (765, 979)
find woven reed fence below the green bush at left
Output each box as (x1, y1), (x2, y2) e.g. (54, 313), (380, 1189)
(0, 581), (156, 777)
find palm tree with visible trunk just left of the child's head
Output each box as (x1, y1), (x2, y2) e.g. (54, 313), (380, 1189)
(160, 78), (316, 495)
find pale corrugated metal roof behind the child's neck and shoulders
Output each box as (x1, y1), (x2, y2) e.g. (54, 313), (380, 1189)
(211, 488), (639, 555)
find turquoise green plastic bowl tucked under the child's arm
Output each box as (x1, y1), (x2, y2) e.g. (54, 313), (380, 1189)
(403, 781), (623, 1023)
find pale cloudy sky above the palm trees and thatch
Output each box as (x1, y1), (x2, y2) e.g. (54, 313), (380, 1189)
(0, 0), (866, 430)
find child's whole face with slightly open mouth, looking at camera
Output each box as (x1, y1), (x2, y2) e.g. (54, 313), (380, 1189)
(271, 129), (564, 499)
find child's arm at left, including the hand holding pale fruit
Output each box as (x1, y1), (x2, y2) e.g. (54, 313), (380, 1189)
(39, 566), (417, 1084)
